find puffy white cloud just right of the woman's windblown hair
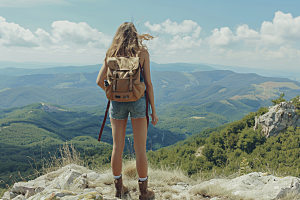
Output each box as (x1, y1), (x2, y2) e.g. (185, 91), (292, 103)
(144, 19), (201, 37)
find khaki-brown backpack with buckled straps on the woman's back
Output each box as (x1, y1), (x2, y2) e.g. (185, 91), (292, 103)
(105, 57), (145, 102)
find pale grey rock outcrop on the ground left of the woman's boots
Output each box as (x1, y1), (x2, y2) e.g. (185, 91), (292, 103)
(2, 164), (107, 200)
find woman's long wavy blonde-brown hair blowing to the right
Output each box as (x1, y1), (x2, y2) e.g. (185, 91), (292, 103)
(106, 22), (154, 57)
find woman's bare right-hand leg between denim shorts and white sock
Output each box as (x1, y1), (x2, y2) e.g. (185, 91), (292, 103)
(131, 117), (148, 178)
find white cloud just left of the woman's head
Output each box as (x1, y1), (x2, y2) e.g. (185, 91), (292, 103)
(52, 21), (111, 48)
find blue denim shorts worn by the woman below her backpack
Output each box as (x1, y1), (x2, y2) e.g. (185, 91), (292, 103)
(109, 95), (151, 119)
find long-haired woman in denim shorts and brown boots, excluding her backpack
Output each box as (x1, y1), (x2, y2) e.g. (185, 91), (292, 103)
(97, 22), (159, 200)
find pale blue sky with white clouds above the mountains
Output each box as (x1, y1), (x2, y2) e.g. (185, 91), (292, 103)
(0, 0), (300, 71)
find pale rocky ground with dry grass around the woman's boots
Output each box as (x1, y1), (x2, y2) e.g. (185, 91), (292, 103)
(1, 164), (300, 200)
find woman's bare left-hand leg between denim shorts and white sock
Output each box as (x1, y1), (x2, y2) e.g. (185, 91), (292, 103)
(110, 118), (127, 176)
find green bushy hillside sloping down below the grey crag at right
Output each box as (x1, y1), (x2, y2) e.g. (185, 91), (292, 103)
(148, 97), (300, 176)
